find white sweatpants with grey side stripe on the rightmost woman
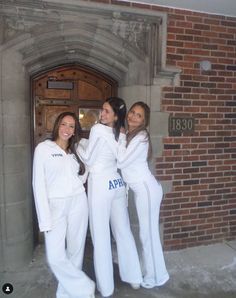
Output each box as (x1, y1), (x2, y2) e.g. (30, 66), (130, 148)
(129, 175), (169, 288)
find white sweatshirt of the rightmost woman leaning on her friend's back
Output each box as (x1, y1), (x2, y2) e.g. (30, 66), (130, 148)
(117, 131), (152, 184)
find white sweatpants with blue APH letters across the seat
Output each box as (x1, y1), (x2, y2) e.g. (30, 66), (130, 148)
(88, 173), (142, 296)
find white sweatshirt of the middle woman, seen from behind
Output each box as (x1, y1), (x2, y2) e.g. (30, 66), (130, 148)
(77, 124), (118, 173)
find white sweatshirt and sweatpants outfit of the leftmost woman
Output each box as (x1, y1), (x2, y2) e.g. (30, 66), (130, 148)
(33, 140), (95, 298)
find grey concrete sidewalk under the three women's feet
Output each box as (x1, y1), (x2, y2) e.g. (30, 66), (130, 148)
(0, 241), (236, 298)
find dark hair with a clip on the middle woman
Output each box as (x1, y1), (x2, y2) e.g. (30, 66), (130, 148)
(105, 97), (127, 141)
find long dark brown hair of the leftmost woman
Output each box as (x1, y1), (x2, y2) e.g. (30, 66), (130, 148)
(52, 112), (85, 175)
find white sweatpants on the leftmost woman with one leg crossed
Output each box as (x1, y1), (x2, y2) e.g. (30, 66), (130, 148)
(44, 192), (95, 298)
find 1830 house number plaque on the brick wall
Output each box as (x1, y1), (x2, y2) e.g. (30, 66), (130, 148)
(169, 116), (194, 136)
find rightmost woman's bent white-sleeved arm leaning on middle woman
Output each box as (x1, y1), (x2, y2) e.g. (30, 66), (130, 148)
(117, 134), (148, 169)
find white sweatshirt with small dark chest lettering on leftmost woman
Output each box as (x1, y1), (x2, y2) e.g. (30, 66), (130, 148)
(32, 140), (85, 231)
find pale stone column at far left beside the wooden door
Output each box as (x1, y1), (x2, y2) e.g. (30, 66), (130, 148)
(0, 48), (33, 270)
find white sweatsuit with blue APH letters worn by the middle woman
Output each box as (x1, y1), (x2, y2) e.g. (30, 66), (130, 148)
(78, 124), (142, 296)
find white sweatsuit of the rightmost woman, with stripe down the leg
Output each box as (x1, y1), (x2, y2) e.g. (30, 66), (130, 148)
(118, 131), (169, 288)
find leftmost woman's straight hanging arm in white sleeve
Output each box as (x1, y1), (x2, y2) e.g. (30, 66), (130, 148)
(32, 147), (52, 232)
